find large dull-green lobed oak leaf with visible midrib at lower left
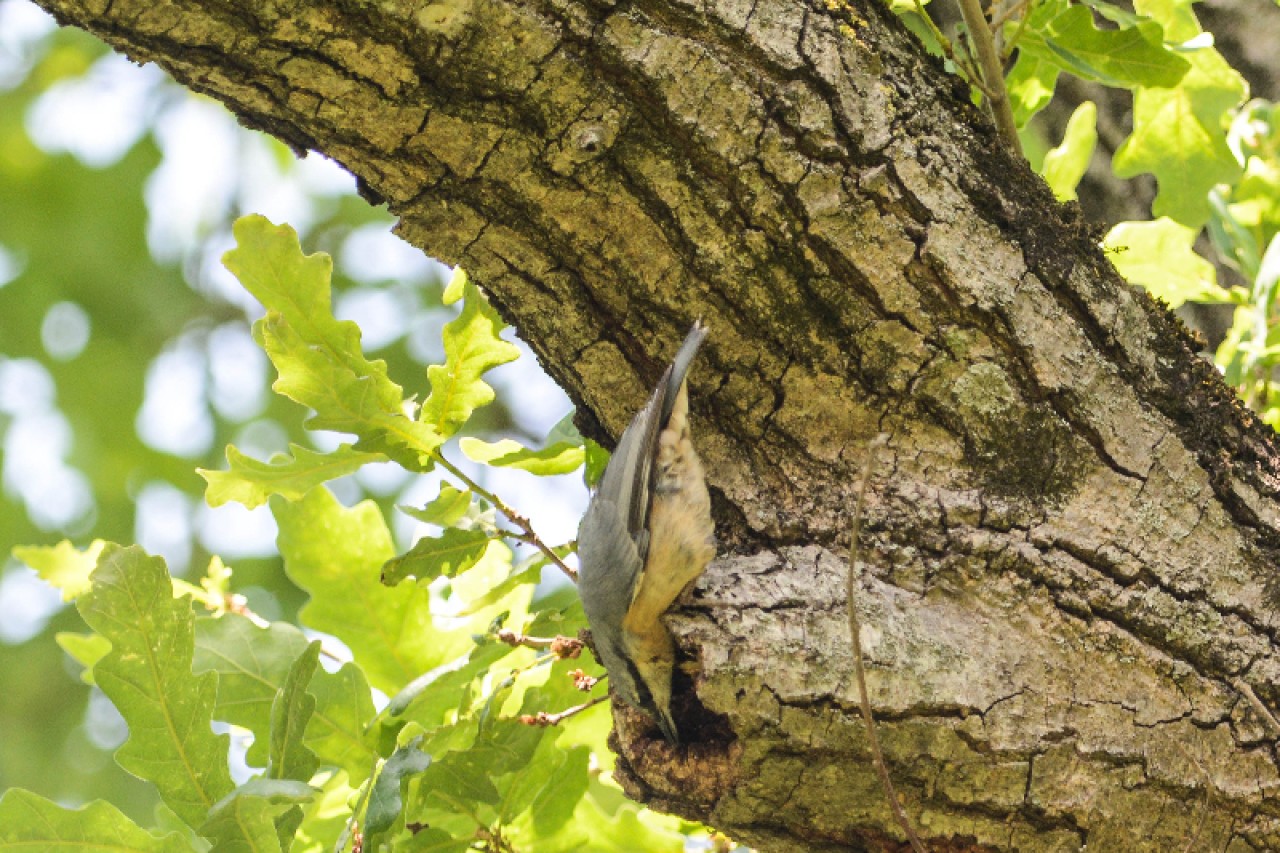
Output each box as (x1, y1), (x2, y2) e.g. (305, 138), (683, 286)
(77, 544), (233, 829)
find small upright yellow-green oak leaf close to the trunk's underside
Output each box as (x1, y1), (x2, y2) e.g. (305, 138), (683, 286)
(419, 269), (520, 437)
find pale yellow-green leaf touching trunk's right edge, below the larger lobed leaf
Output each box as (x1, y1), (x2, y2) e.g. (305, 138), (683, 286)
(1103, 216), (1233, 307)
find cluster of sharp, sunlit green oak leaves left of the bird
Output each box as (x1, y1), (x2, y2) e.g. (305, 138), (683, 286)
(0, 215), (698, 853)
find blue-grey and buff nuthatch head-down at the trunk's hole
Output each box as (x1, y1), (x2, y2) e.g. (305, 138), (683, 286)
(577, 323), (716, 744)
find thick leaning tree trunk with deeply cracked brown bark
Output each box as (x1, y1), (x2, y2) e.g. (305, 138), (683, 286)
(32, 0), (1280, 850)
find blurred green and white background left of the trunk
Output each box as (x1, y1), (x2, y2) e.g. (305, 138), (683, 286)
(0, 0), (586, 821)
